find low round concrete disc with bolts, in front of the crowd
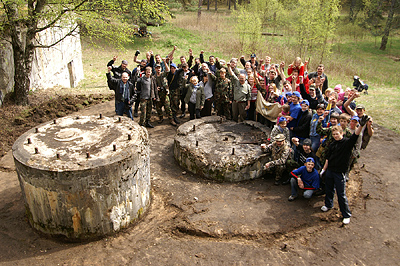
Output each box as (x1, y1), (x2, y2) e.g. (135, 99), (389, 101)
(174, 116), (270, 182)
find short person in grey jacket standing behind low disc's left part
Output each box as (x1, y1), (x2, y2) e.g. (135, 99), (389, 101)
(185, 76), (206, 120)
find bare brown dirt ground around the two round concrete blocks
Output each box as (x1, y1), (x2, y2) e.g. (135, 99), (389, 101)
(0, 102), (400, 265)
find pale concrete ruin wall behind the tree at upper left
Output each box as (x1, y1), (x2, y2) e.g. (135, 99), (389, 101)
(0, 25), (84, 106)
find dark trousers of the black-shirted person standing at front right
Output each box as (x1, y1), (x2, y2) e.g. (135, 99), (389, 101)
(325, 169), (351, 218)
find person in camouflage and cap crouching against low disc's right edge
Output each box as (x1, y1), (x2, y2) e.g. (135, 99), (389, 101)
(261, 134), (290, 186)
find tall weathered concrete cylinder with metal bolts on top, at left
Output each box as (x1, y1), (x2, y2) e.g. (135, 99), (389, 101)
(13, 116), (150, 239)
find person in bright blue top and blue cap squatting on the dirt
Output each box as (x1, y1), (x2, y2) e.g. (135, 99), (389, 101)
(288, 157), (319, 201)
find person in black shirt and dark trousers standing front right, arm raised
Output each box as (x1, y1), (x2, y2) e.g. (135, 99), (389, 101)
(321, 117), (369, 224)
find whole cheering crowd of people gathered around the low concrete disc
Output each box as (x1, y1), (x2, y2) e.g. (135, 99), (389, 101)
(107, 46), (374, 224)
